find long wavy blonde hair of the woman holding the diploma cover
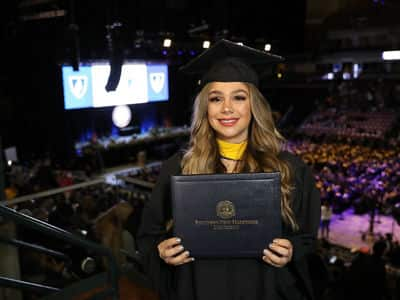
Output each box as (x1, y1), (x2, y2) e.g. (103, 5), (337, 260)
(181, 83), (298, 230)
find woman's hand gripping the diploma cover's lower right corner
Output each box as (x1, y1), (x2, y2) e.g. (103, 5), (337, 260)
(263, 239), (293, 268)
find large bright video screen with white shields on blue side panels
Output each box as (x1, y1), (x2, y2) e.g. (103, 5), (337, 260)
(62, 62), (169, 109)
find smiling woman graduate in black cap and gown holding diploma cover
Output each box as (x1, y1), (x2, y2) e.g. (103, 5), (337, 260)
(138, 40), (320, 300)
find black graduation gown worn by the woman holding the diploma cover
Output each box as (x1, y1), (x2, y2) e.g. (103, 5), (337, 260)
(137, 152), (321, 300)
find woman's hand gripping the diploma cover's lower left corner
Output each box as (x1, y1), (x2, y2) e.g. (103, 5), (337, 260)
(157, 237), (194, 266)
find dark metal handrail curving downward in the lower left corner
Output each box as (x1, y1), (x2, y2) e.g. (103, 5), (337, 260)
(0, 205), (119, 300)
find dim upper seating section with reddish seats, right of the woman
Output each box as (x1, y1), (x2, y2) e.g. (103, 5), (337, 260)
(298, 80), (400, 141)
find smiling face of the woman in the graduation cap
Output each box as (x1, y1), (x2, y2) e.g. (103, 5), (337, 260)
(207, 82), (251, 143)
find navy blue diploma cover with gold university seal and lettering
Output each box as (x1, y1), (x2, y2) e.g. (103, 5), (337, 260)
(171, 172), (282, 258)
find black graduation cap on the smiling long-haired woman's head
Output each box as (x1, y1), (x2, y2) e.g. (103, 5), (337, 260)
(180, 39), (283, 87)
